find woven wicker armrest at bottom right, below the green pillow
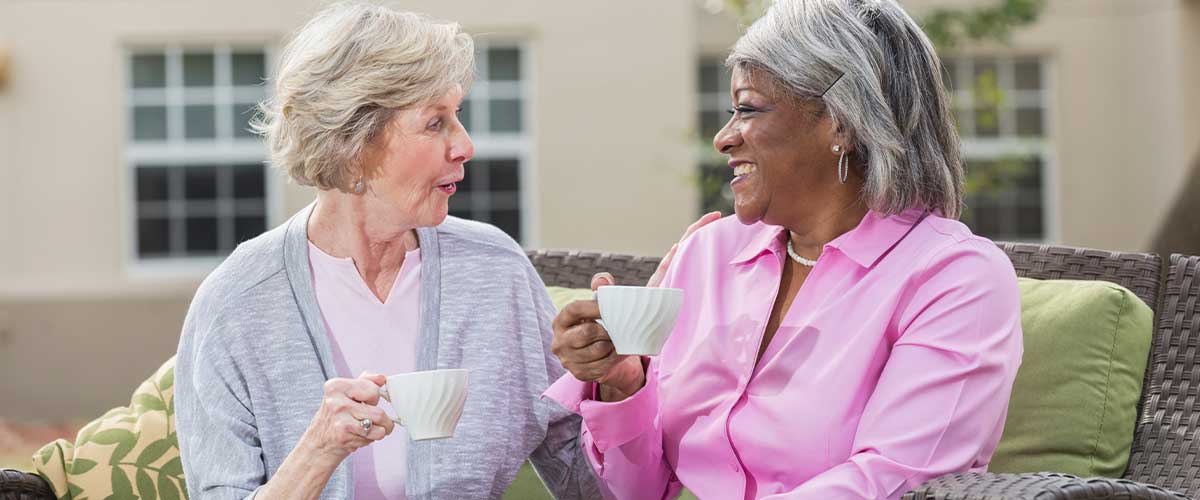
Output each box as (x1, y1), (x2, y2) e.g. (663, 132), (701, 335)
(904, 472), (1187, 500)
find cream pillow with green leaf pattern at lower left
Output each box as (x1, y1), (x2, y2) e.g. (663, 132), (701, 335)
(34, 356), (187, 500)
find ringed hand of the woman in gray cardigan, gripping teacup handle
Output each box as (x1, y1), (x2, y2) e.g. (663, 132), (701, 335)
(301, 373), (395, 463)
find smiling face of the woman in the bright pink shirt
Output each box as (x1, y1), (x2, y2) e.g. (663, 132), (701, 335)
(713, 67), (853, 225)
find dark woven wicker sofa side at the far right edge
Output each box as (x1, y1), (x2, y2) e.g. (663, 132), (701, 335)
(1126, 255), (1200, 498)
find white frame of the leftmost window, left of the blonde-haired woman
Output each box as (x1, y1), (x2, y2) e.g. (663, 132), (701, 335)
(119, 41), (283, 279)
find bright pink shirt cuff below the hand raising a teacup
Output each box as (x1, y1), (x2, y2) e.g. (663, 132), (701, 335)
(578, 372), (659, 453)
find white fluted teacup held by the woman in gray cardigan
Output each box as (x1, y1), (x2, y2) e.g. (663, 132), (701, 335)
(379, 368), (469, 441)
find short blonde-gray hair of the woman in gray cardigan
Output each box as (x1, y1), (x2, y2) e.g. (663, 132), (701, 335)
(252, 1), (475, 191)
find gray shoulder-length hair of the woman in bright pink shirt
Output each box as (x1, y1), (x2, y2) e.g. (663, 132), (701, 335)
(726, 0), (964, 218)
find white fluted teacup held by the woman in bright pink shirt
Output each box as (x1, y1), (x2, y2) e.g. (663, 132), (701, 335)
(596, 287), (683, 356)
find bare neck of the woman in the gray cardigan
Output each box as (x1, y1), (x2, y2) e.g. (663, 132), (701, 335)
(308, 189), (419, 274)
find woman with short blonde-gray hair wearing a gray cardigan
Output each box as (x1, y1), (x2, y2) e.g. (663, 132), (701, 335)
(175, 4), (598, 499)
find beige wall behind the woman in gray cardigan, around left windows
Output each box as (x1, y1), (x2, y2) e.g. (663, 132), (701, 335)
(0, 0), (697, 417)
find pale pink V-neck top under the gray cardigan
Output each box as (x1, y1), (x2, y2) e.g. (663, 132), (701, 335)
(308, 241), (421, 500)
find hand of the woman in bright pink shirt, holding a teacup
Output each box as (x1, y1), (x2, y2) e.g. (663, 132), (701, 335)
(550, 272), (646, 402)
